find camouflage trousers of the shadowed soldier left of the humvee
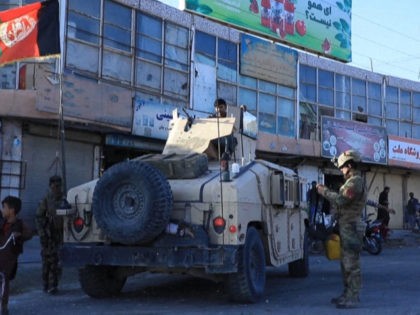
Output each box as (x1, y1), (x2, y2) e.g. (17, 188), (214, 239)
(41, 240), (61, 290)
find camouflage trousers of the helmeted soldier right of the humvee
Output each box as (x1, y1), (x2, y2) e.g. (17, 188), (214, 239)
(340, 223), (363, 298)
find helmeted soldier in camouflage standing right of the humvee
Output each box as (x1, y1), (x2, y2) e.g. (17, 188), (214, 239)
(317, 150), (367, 308)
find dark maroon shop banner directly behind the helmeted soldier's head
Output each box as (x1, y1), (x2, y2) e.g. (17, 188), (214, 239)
(321, 116), (387, 164)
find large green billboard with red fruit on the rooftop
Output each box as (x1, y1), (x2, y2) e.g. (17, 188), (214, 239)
(185, 0), (351, 62)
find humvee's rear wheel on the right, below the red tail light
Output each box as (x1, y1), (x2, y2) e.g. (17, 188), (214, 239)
(226, 227), (265, 303)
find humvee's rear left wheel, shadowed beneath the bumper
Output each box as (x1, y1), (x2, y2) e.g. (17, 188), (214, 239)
(79, 265), (127, 298)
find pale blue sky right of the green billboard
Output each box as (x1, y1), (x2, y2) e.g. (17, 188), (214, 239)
(350, 0), (420, 82)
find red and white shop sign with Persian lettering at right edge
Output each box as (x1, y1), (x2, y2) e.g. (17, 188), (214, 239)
(388, 136), (420, 169)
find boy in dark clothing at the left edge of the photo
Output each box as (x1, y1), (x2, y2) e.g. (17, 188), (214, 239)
(0, 196), (23, 315)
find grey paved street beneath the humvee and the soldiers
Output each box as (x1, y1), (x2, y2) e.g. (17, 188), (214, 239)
(9, 231), (420, 315)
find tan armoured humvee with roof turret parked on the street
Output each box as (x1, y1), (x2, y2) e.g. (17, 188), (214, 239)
(57, 110), (309, 303)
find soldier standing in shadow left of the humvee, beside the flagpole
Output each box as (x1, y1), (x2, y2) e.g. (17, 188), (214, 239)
(36, 175), (63, 294)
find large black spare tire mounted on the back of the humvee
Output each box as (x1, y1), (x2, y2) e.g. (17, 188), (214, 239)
(92, 161), (173, 245)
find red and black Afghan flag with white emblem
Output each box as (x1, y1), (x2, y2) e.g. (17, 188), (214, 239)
(0, 0), (60, 65)
